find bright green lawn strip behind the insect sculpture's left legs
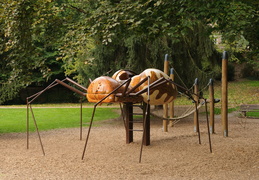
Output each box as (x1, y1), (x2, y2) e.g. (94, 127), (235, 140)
(0, 107), (119, 133)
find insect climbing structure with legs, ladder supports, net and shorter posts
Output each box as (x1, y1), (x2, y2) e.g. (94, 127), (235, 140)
(27, 53), (230, 162)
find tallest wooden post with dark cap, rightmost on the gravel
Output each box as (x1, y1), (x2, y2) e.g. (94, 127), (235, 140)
(221, 51), (228, 137)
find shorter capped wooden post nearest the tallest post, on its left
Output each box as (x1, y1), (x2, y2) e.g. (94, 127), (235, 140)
(209, 79), (215, 134)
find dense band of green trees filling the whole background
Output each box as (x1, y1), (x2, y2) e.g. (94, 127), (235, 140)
(0, 0), (259, 104)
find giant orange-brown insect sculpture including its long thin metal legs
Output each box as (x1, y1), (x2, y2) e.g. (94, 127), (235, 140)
(27, 51), (231, 162)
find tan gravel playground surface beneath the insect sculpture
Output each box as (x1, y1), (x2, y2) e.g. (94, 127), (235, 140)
(0, 113), (259, 180)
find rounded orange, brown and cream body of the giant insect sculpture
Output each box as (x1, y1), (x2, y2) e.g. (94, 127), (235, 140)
(86, 69), (177, 105)
